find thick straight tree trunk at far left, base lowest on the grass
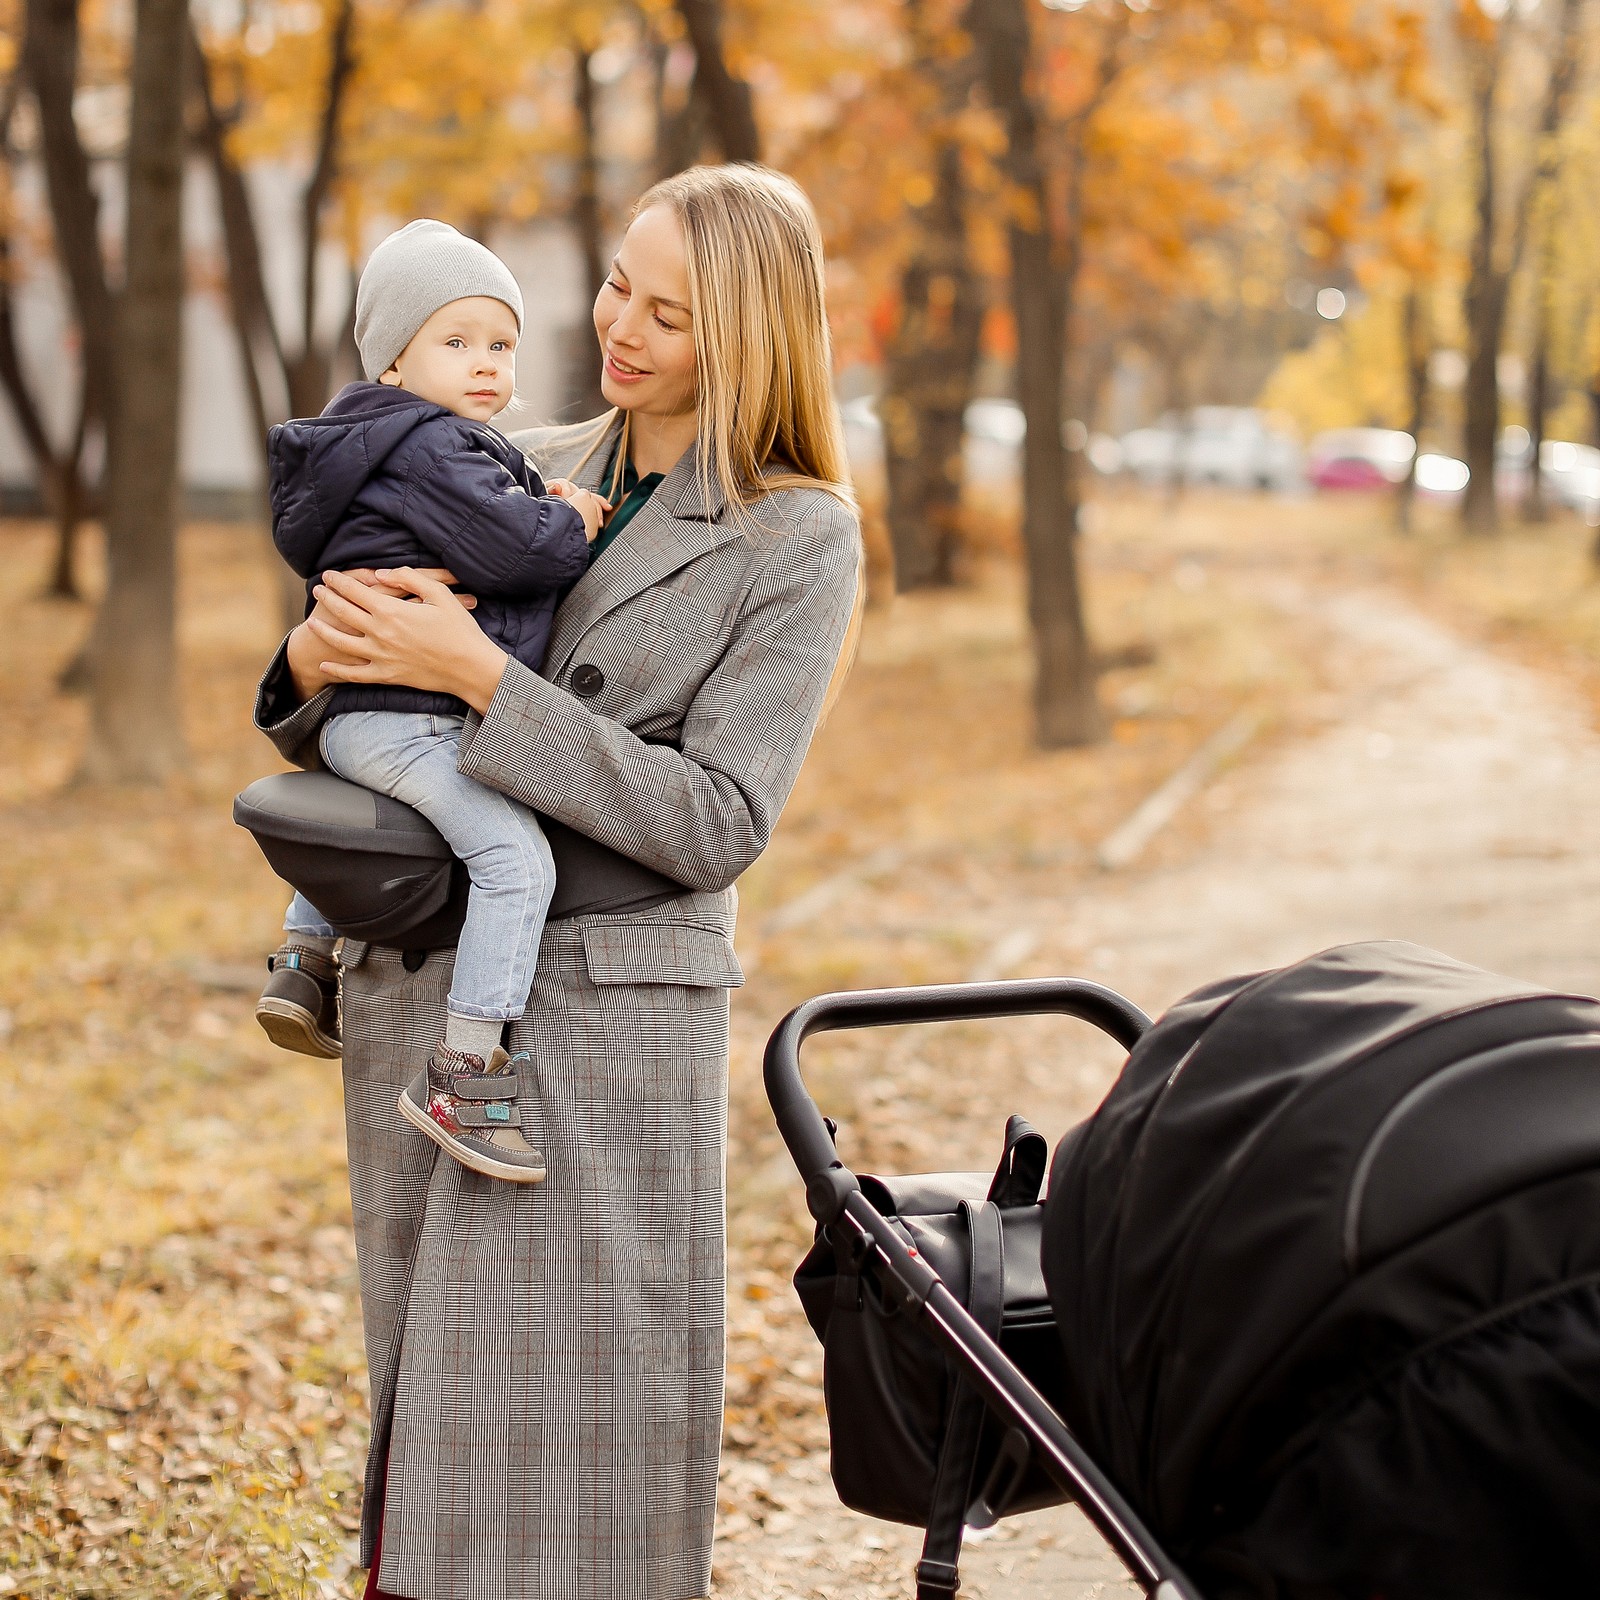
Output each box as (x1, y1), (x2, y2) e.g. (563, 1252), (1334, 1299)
(83, 0), (187, 782)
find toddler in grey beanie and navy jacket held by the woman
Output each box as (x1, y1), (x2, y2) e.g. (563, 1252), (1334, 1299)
(256, 221), (610, 1182)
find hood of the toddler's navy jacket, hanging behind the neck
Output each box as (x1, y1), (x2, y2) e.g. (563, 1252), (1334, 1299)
(267, 382), (454, 578)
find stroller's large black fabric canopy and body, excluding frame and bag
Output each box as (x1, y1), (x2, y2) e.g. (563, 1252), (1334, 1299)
(1043, 942), (1600, 1600)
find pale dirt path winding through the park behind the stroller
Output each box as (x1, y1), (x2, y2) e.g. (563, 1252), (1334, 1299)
(717, 587), (1600, 1600)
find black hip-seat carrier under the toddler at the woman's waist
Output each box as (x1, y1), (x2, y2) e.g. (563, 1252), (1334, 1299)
(234, 771), (685, 950)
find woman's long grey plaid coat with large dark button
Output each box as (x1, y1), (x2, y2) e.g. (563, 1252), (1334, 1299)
(256, 424), (859, 1600)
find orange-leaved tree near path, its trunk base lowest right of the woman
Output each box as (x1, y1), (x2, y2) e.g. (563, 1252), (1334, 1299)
(968, 0), (1419, 744)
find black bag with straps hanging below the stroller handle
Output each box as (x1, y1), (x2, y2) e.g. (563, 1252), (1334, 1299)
(795, 1117), (1064, 1592)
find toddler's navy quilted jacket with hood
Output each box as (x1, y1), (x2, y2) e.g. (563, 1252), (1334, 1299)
(267, 384), (589, 714)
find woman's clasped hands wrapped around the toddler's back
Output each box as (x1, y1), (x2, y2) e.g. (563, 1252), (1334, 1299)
(302, 566), (509, 712)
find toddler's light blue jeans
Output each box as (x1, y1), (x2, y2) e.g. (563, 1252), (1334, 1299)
(283, 710), (555, 1022)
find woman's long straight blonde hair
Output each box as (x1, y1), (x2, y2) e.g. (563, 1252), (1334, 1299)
(632, 165), (856, 522)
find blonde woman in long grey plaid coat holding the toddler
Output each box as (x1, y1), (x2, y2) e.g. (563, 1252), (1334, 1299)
(256, 166), (859, 1600)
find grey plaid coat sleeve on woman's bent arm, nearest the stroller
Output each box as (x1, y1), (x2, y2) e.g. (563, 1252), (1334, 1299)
(461, 507), (861, 890)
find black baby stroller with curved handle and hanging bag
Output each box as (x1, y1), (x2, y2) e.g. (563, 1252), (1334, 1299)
(765, 942), (1600, 1600)
